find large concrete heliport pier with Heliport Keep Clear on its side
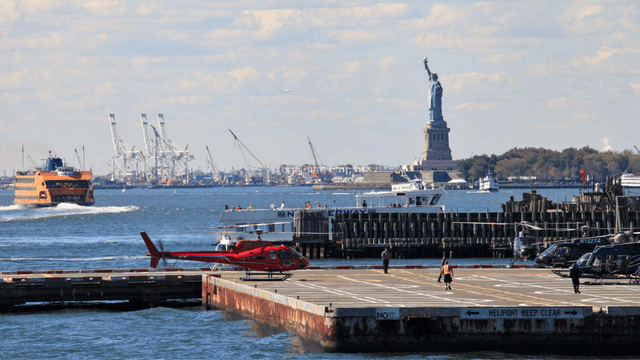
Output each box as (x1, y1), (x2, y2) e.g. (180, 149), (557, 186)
(202, 267), (640, 355)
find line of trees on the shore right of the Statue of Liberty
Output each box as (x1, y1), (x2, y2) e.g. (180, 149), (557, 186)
(458, 146), (640, 182)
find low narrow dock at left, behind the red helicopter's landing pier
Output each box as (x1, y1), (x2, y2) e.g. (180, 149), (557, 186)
(0, 268), (215, 312)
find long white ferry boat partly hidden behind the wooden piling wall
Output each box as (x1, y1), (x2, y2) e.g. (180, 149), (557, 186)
(218, 180), (445, 248)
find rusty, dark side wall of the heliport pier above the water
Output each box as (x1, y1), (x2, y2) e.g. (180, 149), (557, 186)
(202, 275), (640, 355)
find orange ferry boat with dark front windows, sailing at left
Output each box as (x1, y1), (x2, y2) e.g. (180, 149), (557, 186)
(13, 155), (95, 206)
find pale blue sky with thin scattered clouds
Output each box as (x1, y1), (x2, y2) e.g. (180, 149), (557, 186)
(0, 0), (640, 175)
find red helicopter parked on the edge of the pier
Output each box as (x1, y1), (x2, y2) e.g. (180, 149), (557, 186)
(140, 231), (309, 280)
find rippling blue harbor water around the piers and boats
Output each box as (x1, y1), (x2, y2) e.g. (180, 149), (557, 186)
(0, 187), (578, 359)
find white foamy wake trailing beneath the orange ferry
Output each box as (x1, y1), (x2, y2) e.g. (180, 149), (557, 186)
(0, 204), (140, 222)
